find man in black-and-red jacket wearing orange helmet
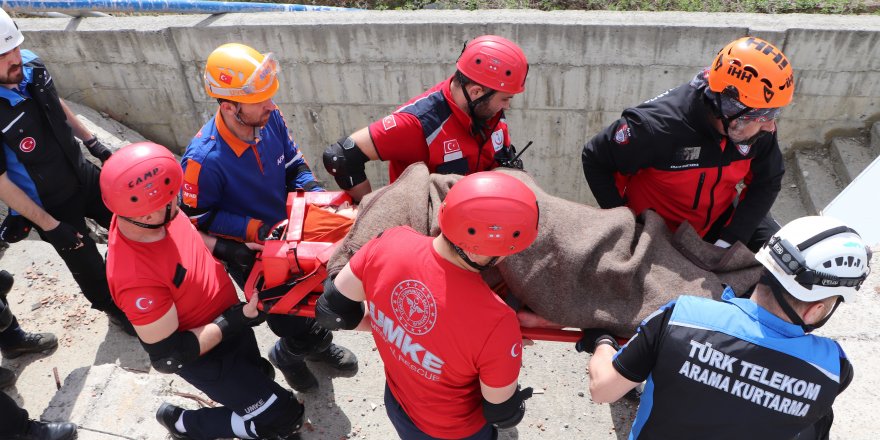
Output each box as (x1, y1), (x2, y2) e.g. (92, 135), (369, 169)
(581, 37), (794, 252)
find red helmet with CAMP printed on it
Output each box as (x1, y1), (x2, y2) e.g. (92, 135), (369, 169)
(101, 142), (183, 217)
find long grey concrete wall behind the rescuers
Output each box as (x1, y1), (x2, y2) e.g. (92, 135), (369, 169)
(18, 11), (880, 202)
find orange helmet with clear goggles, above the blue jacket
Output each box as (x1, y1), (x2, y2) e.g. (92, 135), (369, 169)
(205, 43), (281, 104)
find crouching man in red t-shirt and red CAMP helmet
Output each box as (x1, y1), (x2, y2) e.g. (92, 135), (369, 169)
(101, 142), (304, 439)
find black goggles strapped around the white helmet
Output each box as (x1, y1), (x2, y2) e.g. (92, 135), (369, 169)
(767, 232), (868, 290)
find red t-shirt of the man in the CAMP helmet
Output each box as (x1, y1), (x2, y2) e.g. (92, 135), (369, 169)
(107, 215), (238, 331)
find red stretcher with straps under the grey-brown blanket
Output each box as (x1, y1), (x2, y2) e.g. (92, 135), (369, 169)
(244, 191), (581, 343)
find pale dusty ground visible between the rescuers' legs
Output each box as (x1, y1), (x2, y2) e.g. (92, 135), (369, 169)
(0, 240), (880, 440)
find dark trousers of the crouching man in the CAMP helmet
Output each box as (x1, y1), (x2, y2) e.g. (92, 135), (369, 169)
(177, 328), (304, 439)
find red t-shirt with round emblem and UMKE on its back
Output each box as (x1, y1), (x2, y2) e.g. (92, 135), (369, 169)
(349, 226), (522, 438)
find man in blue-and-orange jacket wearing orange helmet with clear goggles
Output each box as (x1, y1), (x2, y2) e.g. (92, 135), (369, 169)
(181, 43), (357, 391)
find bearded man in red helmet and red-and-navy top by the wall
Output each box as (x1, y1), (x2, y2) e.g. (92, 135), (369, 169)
(324, 35), (529, 202)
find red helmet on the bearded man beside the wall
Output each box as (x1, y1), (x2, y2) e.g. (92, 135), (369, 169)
(455, 35), (529, 95)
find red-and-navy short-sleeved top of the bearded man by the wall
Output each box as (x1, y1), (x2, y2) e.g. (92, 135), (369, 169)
(369, 77), (510, 182)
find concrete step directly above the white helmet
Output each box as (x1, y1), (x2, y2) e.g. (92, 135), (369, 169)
(792, 149), (843, 215)
